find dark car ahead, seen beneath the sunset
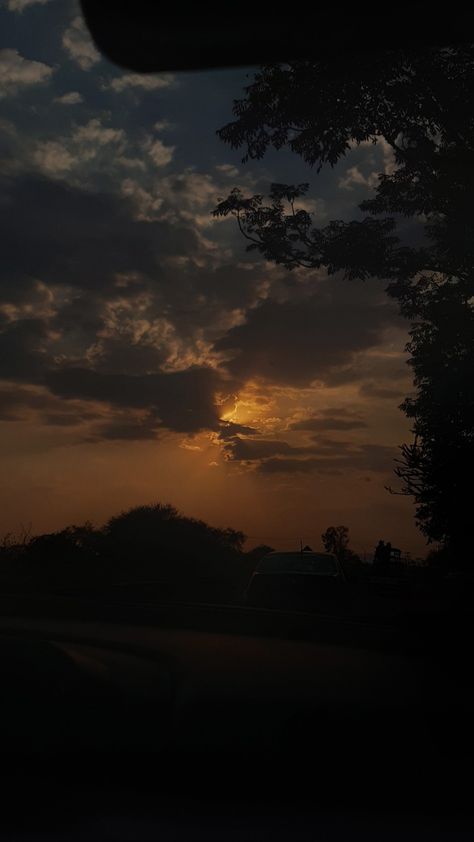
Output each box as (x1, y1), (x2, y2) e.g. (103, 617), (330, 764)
(244, 550), (347, 612)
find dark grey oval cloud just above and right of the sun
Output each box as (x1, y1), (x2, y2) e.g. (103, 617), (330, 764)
(214, 279), (399, 386)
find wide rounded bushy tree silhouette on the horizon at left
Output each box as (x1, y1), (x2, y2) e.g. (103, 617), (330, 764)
(0, 503), (248, 596)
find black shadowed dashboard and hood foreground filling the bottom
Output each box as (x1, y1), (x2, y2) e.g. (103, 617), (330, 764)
(0, 597), (474, 840)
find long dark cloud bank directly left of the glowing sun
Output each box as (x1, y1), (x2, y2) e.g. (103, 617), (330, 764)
(46, 367), (220, 432)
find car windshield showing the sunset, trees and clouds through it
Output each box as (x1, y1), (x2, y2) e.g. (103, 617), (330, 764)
(0, 0), (474, 632)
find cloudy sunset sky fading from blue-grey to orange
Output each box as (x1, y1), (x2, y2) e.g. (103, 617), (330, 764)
(0, 0), (425, 554)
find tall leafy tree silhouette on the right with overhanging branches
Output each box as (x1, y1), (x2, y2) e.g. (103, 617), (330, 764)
(214, 45), (474, 557)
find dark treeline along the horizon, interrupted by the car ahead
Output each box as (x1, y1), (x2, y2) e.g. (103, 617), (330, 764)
(0, 503), (460, 600)
